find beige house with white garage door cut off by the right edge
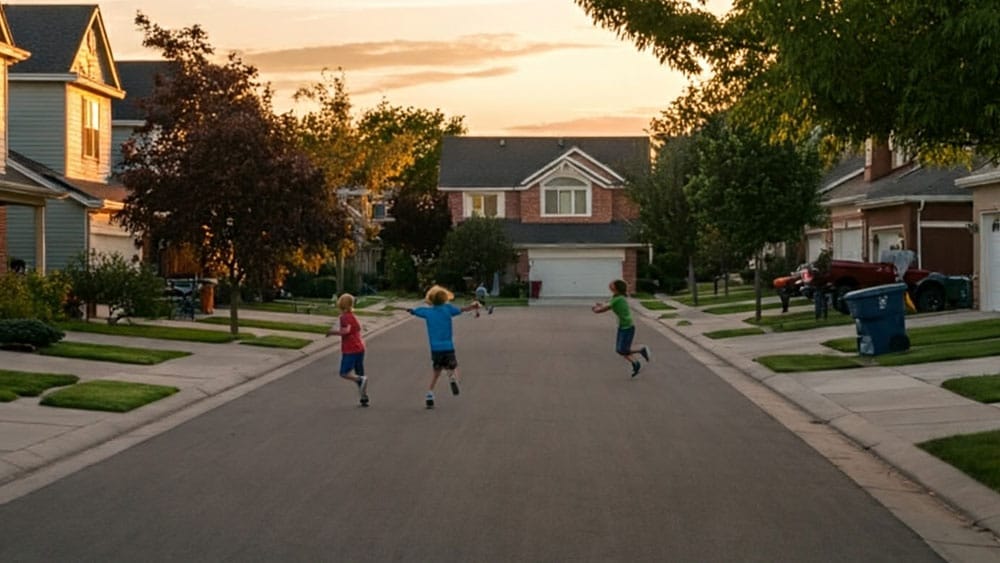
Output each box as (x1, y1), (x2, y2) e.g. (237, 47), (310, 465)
(955, 165), (1000, 312)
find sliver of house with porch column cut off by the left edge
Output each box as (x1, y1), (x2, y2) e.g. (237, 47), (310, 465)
(0, 6), (59, 274)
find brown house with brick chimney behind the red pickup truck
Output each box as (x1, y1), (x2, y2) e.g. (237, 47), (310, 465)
(806, 144), (973, 275)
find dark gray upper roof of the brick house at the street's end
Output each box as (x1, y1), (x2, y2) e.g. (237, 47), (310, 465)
(438, 137), (650, 188)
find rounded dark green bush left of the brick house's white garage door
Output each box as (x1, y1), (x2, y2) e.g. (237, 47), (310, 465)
(438, 217), (515, 290)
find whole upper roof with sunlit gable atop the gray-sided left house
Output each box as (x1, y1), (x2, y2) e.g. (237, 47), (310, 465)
(6, 4), (121, 90)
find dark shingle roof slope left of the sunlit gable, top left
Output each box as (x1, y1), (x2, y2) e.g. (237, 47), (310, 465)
(4, 4), (97, 74)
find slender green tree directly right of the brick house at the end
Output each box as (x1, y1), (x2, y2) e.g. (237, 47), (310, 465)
(628, 136), (699, 305)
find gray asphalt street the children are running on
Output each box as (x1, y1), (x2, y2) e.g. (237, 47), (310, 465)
(0, 307), (939, 562)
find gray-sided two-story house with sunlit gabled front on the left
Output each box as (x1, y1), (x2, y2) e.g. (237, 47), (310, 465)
(6, 5), (139, 270)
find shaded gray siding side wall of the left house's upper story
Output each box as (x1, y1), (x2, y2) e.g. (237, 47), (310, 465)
(9, 82), (66, 174)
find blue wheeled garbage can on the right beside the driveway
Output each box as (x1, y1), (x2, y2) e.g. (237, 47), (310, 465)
(844, 283), (910, 356)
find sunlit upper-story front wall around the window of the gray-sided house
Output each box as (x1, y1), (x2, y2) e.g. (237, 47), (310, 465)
(65, 86), (111, 182)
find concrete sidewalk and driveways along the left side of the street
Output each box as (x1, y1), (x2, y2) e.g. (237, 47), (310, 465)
(0, 303), (413, 492)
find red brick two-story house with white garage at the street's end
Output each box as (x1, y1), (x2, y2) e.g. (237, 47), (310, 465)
(438, 137), (651, 298)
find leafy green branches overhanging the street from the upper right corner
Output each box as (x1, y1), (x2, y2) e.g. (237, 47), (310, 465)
(576, 0), (1000, 158)
